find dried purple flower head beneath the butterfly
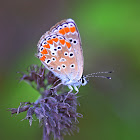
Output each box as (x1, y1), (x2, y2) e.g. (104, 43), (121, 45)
(9, 65), (82, 140)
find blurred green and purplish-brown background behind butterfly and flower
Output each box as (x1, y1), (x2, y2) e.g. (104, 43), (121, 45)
(0, 0), (140, 140)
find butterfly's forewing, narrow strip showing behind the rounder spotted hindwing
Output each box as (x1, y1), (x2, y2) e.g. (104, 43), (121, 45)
(50, 19), (84, 80)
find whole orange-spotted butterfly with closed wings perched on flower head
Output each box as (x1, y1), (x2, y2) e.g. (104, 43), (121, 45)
(37, 19), (109, 93)
